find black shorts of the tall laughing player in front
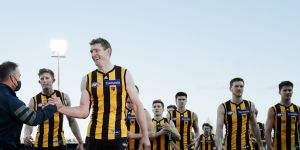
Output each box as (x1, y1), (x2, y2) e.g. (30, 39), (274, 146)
(85, 137), (127, 150)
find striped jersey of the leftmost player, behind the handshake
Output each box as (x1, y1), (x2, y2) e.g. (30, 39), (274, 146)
(32, 90), (66, 148)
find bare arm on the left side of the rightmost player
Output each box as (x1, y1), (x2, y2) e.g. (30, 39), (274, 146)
(265, 107), (275, 150)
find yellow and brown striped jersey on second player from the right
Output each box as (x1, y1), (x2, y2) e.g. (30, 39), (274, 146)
(223, 100), (253, 150)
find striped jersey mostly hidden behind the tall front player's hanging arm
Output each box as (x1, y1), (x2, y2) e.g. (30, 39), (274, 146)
(126, 109), (140, 150)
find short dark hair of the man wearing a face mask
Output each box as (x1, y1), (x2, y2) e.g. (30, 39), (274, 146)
(0, 61), (18, 82)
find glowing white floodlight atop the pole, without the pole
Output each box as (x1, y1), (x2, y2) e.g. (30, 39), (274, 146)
(50, 40), (67, 56)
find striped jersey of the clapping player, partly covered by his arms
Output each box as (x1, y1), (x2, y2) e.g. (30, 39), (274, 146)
(151, 118), (169, 150)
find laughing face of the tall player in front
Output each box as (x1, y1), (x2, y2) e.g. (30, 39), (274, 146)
(90, 44), (110, 66)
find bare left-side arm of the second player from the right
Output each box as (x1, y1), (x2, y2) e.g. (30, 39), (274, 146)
(216, 104), (225, 149)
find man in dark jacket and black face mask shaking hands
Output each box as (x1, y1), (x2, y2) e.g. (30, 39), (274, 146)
(0, 61), (56, 150)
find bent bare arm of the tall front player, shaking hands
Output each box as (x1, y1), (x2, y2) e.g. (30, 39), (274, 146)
(48, 76), (90, 119)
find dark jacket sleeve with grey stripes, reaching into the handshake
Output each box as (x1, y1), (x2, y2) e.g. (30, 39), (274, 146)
(10, 98), (57, 126)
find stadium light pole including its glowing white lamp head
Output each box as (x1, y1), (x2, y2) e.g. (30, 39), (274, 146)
(50, 40), (67, 90)
